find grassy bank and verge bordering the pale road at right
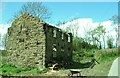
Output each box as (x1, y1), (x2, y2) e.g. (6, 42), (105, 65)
(82, 48), (120, 76)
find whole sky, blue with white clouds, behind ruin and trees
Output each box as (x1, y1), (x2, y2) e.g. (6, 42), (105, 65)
(0, 2), (118, 49)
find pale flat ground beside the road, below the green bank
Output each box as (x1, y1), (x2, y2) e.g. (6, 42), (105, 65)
(82, 62), (112, 76)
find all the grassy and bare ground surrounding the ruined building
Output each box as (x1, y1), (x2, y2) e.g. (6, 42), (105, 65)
(0, 49), (120, 76)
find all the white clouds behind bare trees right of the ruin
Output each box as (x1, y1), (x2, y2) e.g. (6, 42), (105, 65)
(60, 18), (116, 47)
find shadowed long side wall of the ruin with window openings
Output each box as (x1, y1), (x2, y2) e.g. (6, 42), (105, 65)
(45, 24), (72, 64)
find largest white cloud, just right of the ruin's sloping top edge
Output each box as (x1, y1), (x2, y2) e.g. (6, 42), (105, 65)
(60, 18), (99, 37)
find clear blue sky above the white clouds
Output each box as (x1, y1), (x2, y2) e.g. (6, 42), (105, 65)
(0, 2), (118, 24)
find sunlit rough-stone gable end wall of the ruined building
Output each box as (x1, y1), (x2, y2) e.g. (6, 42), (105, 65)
(7, 14), (45, 68)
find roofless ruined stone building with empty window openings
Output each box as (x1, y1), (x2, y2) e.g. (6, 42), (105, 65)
(7, 13), (72, 68)
